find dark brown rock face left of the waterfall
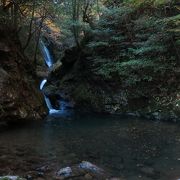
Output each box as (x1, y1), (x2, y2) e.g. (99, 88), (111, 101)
(0, 30), (47, 122)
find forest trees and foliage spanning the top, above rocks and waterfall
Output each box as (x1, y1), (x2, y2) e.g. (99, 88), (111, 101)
(0, 0), (180, 115)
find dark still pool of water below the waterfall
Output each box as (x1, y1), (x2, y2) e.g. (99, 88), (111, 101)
(0, 114), (180, 180)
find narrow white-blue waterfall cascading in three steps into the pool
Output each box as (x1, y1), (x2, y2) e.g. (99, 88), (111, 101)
(40, 40), (66, 114)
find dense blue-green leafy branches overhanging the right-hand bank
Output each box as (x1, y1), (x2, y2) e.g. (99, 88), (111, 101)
(87, 0), (179, 86)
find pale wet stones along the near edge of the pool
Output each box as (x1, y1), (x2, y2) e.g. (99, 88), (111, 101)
(0, 161), (123, 180)
